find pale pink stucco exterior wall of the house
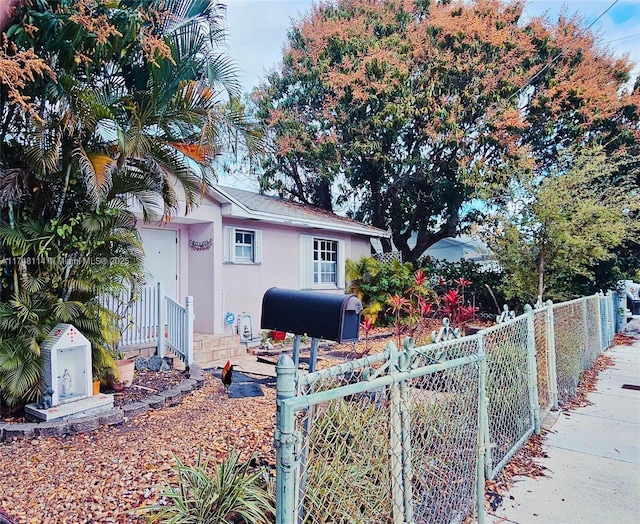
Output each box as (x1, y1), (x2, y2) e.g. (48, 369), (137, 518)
(139, 192), (371, 336)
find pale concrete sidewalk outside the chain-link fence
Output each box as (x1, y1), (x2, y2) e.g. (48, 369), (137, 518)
(486, 316), (640, 524)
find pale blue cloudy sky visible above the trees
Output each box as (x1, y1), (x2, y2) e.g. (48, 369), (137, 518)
(221, 0), (640, 92)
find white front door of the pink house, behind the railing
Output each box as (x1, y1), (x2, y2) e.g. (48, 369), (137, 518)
(141, 228), (178, 301)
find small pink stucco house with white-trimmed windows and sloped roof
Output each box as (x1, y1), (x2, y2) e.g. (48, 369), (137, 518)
(122, 186), (389, 366)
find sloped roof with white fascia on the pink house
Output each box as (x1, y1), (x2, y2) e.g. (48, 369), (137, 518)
(212, 186), (391, 238)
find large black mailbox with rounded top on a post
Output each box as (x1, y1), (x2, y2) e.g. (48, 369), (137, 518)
(260, 287), (362, 342)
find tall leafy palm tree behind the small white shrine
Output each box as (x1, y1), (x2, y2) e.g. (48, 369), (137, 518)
(0, 0), (259, 406)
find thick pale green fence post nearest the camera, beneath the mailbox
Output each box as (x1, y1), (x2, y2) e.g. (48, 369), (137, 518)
(273, 355), (296, 524)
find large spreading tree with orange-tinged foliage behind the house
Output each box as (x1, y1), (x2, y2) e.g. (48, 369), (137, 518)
(254, 0), (638, 261)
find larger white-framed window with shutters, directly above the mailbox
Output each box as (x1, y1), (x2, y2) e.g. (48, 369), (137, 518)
(300, 235), (345, 289)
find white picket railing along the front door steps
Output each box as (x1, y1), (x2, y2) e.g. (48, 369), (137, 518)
(100, 282), (193, 365)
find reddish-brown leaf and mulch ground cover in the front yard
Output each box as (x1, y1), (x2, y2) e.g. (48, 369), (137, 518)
(0, 376), (275, 524)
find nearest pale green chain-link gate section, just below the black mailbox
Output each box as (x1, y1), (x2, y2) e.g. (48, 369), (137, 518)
(276, 336), (486, 524)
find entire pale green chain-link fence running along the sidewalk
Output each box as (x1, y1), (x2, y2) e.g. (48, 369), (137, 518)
(275, 294), (615, 524)
